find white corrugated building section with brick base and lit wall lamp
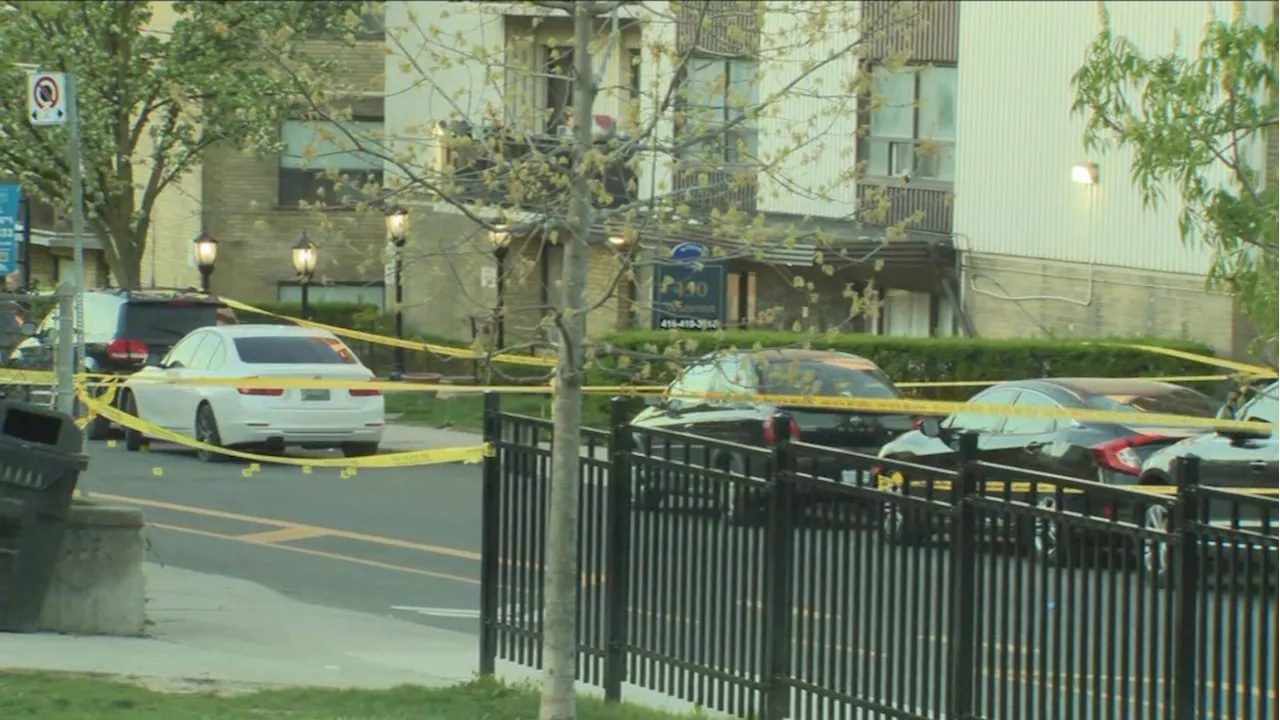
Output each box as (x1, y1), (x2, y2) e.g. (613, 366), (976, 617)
(955, 1), (1264, 352)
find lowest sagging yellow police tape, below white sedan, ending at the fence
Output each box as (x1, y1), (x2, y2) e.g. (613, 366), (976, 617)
(79, 392), (493, 470)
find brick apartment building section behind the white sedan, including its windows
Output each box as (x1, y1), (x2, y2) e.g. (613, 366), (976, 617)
(185, 10), (387, 306)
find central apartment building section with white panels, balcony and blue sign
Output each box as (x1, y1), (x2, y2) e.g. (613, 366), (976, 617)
(387, 0), (959, 341)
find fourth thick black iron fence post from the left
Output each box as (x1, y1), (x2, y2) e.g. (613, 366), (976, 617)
(947, 432), (982, 720)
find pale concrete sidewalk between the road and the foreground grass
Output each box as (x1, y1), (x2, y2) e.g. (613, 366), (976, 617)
(0, 564), (716, 715)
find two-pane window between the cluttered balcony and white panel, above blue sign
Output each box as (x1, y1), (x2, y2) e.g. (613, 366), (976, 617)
(680, 58), (760, 163)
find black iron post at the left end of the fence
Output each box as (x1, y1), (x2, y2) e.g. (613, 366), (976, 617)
(480, 391), (502, 675)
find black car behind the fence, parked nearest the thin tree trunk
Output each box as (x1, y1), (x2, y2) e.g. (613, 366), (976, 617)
(631, 350), (914, 520)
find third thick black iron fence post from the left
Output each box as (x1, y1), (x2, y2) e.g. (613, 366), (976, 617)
(762, 414), (795, 720)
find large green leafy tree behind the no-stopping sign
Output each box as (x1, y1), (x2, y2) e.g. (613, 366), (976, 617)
(0, 0), (358, 287)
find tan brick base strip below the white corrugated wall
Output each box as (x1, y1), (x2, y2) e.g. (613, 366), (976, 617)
(964, 255), (1239, 354)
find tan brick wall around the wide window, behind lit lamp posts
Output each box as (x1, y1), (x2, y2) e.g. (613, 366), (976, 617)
(199, 41), (387, 301)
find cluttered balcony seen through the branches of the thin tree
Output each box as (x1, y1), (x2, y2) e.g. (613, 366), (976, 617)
(438, 124), (639, 214)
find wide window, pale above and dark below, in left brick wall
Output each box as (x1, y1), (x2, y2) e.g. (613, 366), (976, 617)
(279, 118), (383, 209)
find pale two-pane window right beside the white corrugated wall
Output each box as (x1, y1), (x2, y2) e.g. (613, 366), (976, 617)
(860, 65), (956, 182)
